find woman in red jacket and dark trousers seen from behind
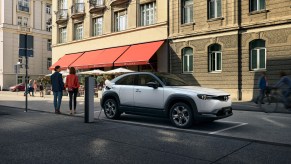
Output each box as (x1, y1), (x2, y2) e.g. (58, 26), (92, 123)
(66, 67), (80, 114)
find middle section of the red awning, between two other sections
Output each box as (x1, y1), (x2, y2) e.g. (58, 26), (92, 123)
(70, 46), (129, 69)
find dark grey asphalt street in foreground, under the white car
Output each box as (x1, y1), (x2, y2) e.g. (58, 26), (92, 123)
(0, 93), (291, 163)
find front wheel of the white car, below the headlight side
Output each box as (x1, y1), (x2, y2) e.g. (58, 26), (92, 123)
(169, 102), (194, 128)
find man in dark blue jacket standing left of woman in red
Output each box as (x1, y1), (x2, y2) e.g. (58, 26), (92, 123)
(51, 66), (64, 114)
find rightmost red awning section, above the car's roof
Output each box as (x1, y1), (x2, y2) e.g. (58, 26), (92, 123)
(114, 41), (164, 66)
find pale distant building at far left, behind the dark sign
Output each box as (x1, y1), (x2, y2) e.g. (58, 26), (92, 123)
(0, 0), (52, 89)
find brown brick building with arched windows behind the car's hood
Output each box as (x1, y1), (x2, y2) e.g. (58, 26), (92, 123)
(169, 0), (291, 100)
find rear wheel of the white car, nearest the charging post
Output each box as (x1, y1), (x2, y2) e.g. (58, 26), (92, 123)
(104, 98), (121, 119)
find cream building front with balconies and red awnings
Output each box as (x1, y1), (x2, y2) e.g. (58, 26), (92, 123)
(52, 0), (168, 72)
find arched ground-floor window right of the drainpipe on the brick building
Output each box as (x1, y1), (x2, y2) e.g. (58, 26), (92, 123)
(250, 39), (266, 70)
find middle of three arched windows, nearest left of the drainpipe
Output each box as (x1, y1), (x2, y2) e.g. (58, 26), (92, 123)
(208, 44), (222, 72)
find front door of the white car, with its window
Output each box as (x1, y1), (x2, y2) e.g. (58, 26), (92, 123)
(133, 74), (164, 109)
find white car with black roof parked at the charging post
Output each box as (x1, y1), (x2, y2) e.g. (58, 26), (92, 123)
(101, 72), (233, 128)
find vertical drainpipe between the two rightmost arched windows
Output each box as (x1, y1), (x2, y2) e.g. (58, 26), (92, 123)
(237, 0), (243, 101)
